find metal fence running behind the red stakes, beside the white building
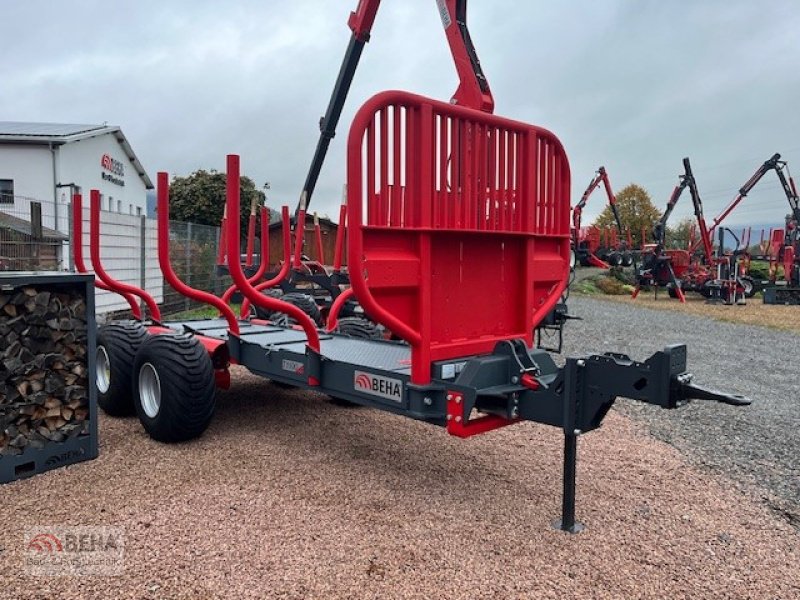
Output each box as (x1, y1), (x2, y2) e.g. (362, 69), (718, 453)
(0, 197), (230, 315)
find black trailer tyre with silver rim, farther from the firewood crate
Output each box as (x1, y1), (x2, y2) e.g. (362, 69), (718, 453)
(133, 334), (216, 443)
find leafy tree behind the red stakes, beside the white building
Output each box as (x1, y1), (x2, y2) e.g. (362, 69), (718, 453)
(169, 169), (280, 234)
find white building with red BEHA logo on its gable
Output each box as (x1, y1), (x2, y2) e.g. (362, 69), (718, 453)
(0, 121), (163, 313)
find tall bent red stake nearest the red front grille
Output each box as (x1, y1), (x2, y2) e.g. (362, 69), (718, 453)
(226, 154), (320, 356)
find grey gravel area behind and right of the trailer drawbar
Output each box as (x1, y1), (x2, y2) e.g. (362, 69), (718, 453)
(565, 295), (800, 527)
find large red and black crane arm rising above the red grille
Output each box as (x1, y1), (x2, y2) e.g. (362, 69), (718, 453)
(298, 0), (494, 210)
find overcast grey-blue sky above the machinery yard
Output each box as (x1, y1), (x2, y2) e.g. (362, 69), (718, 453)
(6, 0), (800, 230)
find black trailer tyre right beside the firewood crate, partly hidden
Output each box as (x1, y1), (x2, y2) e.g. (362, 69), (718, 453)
(94, 321), (148, 417)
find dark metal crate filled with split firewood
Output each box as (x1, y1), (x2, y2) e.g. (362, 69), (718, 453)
(0, 272), (98, 483)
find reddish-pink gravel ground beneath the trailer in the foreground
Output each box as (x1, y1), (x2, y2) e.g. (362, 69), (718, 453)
(0, 358), (800, 600)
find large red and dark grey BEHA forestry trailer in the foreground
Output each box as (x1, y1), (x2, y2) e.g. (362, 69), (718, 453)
(84, 0), (749, 532)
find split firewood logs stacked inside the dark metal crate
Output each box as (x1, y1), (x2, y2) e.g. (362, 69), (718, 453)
(0, 285), (89, 455)
